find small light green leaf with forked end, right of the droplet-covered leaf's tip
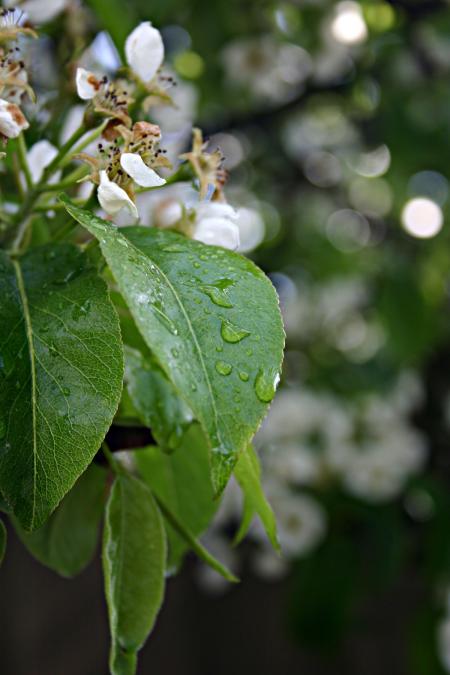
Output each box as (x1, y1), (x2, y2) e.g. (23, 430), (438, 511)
(234, 445), (280, 551)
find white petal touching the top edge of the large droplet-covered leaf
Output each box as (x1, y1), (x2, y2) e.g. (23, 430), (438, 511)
(193, 202), (239, 251)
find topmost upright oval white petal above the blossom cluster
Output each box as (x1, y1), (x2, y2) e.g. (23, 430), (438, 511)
(125, 21), (164, 82)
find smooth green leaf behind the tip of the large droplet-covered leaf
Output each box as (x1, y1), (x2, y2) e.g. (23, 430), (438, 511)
(133, 424), (219, 570)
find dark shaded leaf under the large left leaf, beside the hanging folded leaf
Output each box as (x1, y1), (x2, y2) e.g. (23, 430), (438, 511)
(15, 464), (107, 577)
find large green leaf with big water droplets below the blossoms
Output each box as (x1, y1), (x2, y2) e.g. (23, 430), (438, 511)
(63, 198), (284, 493)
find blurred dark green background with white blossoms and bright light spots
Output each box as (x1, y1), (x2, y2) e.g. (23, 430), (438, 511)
(0, 0), (450, 675)
